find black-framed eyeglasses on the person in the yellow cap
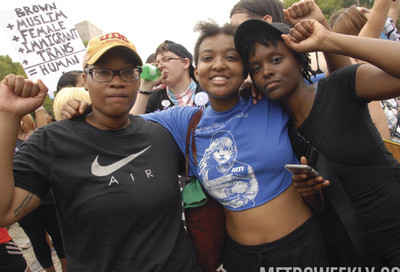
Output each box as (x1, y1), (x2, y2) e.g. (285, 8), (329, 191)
(84, 67), (142, 83)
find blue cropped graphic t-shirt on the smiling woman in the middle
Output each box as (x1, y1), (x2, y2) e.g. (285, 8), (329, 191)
(142, 98), (298, 211)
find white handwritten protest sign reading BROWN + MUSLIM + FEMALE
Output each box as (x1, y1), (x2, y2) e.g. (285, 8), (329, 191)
(0, 2), (85, 97)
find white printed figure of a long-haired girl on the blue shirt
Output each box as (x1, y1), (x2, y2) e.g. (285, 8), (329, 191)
(199, 130), (258, 209)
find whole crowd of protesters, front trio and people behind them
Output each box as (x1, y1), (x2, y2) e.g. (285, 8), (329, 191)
(0, 0), (400, 272)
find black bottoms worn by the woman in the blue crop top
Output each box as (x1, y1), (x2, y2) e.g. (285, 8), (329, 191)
(223, 216), (329, 272)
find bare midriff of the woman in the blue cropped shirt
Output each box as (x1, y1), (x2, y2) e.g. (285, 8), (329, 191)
(225, 185), (312, 245)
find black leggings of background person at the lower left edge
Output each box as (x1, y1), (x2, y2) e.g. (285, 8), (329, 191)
(19, 204), (65, 268)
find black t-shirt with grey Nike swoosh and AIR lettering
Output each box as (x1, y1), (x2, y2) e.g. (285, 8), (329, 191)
(14, 116), (196, 272)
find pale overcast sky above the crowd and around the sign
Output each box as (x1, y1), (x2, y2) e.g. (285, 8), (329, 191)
(0, 0), (239, 61)
